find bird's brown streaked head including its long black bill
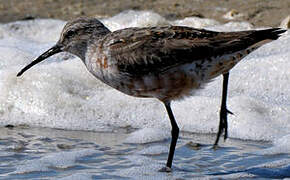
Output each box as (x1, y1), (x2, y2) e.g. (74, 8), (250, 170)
(17, 18), (110, 76)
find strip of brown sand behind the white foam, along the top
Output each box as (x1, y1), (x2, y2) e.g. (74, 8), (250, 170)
(0, 0), (290, 27)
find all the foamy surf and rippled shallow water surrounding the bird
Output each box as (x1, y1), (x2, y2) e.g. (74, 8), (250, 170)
(0, 11), (290, 179)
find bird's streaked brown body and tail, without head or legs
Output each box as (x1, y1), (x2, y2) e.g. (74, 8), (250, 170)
(85, 26), (278, 101)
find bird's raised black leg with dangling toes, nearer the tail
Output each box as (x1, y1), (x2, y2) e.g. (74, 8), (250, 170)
(214, 72), (233, 148)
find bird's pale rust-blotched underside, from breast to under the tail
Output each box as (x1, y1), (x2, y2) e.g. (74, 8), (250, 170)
(85, 41), (255, 101)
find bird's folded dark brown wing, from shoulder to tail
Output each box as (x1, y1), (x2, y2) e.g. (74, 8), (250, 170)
(103, 26), (281, 76)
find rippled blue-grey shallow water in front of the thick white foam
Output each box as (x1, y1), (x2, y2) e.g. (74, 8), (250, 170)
(0, 127), (290, 179)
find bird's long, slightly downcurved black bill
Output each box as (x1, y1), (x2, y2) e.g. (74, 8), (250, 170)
(17, 45), (62, 77)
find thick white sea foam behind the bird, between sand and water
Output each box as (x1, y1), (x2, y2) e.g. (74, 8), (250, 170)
(0, 11), (290, 153)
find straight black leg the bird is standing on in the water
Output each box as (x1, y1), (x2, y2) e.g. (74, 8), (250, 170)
(160, 102), (179, 172)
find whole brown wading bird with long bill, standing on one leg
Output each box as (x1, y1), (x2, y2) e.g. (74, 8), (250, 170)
(17, 18), (285, 171)
